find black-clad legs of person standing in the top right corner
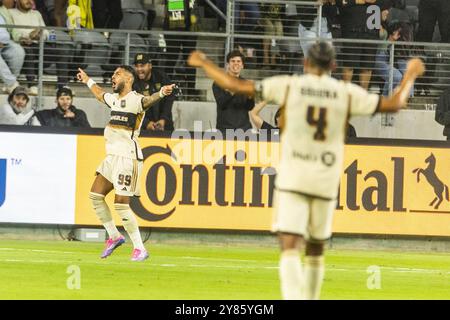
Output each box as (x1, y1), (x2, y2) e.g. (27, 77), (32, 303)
(417, 0), (450, 43)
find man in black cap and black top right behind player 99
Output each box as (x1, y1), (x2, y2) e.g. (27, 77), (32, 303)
(134, 53), (175, 131)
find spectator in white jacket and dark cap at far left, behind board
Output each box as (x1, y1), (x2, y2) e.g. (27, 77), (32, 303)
(0, 87), (40, 126)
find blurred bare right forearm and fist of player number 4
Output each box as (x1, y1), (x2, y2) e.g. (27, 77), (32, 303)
(378, 58), (425, 112)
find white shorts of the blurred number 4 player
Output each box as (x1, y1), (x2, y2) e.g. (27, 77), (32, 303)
(272, 190), (336, 241)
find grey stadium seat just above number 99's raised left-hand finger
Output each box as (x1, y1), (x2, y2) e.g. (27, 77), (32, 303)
(73, 31), (111, 76)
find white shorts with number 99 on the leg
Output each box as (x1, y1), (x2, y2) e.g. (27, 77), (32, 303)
(97, 155), (142, 197)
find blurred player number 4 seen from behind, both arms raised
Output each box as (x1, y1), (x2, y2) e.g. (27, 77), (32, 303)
(188, 42), (425, 299)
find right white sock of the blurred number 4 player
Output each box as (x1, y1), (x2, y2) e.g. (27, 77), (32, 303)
(305, 256), (325, 300)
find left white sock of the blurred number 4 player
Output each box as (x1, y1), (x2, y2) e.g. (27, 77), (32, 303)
(280, 249), (304, 300)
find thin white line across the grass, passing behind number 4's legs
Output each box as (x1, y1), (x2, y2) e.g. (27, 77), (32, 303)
(0, 258), (450, 274)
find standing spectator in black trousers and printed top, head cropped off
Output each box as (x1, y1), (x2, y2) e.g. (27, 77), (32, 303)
(164, 0), (197, 100)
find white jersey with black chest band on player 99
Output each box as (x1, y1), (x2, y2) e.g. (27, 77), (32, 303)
(103, 91), (145, 160)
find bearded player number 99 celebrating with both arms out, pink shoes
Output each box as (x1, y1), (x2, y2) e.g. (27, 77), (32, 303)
(77, 66), (174, 261)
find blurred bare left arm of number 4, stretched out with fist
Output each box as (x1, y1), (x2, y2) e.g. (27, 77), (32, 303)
(188, 51), (255, 97)
